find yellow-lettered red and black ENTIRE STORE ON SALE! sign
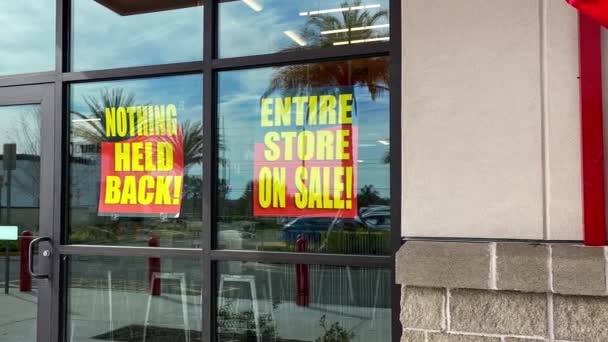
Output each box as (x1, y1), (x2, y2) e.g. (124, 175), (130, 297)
(253, 90), (357, 217)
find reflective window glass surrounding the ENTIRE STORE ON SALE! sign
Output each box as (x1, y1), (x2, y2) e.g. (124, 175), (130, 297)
(217, 57), (392, 255)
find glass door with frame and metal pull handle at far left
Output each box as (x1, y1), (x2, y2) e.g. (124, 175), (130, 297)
(0, 85), (55, 342)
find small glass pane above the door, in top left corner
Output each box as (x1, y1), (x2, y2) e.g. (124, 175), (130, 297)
(0, 0), (55, 75)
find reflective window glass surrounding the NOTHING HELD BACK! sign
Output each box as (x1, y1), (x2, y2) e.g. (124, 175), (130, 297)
(69, 75), (203, 248)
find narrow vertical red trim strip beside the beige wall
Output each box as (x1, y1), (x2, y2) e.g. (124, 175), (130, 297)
(579, 13), (606, 246)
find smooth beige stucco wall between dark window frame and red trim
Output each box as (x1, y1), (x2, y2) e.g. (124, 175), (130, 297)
(402, 0), (582, 240)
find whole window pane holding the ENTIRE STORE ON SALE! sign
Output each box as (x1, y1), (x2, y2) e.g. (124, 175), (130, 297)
(216, 58), (391, 254)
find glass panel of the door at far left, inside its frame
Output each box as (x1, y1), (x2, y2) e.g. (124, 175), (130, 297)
(0, 105), (41, 342)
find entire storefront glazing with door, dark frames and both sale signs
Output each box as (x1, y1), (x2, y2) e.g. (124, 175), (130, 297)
(0, 0), (401, 342)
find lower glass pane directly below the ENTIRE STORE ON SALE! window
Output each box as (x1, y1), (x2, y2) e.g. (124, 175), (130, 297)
(216, 261), (391, 342)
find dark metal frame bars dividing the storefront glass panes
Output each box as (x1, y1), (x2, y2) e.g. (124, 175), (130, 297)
(0, 0), (402, 342)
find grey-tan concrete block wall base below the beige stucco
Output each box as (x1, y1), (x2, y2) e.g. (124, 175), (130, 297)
(397, 241), (608, 342)
